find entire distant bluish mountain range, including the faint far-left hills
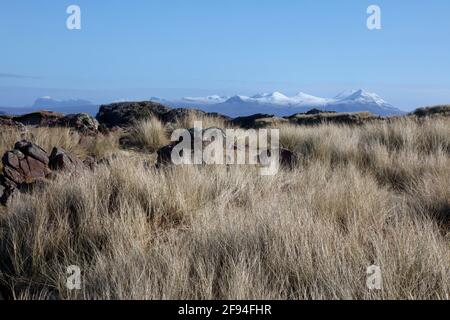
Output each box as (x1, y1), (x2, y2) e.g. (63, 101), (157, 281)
(0, 89), (405, 117)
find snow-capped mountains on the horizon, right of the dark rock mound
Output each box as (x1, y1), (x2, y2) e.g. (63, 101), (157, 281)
(172, 89), (403, 116)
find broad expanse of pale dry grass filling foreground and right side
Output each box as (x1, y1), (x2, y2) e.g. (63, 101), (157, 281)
(0, 115), (450, 299)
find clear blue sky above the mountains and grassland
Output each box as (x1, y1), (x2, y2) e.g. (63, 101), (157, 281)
(0, 0), (450, 109)
